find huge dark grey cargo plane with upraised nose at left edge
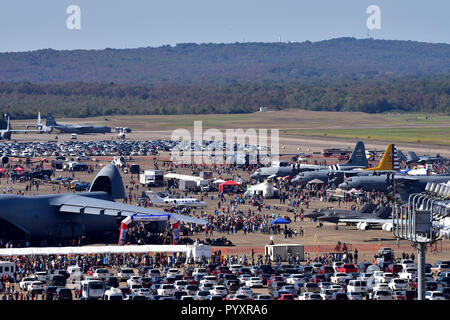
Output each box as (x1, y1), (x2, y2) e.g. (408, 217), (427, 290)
(0, 164), (207, 239)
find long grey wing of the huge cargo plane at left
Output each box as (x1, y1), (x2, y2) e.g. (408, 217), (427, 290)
(50, 194), (208, 225)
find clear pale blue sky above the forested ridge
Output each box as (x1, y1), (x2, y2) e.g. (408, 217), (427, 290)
(0, 0), (450, 52)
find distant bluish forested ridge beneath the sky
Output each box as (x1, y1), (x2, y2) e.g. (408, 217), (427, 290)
(0, 38), (450, 85)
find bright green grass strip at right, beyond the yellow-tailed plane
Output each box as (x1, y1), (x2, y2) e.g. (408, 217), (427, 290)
(280, 127), (450, 145)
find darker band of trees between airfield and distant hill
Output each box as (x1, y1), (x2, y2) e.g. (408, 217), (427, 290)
(0, 76), (450, 119)
